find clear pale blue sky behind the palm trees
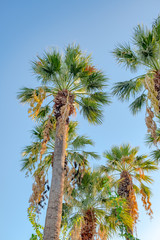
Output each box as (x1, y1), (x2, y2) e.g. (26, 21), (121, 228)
(0, 0), (160, 240)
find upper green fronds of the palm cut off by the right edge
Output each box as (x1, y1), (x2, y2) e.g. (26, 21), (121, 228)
(113, 17), (160, 72)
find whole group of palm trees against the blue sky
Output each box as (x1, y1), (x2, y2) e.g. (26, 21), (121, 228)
(18, 17), (160, 240)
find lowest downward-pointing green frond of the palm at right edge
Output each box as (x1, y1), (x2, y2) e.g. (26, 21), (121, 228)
(129, 93), (147, 115)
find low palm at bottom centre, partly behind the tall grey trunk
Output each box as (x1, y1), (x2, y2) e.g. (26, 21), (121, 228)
(62, 170), (132, 240)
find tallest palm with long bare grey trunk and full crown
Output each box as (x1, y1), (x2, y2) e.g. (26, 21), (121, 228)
(18, 45), (109, 240)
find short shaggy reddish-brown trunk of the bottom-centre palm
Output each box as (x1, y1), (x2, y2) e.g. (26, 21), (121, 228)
(81, 209), (96, 240)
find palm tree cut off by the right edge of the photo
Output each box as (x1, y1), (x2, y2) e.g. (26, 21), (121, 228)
(113, 17), (160, 142)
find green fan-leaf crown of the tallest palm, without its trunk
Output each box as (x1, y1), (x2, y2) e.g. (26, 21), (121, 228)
(18, 45), (110, 123)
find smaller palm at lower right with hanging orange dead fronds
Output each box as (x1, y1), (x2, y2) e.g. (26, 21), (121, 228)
(101, 144), (158, 239)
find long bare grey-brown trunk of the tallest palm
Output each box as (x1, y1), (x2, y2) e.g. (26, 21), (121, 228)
(43, 122), (68, 240)
